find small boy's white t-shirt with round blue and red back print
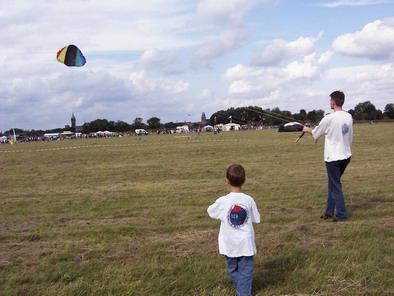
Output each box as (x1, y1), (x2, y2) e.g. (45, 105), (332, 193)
(207, 192), (260, 257)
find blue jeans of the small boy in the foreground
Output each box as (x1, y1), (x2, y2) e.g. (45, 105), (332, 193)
(226, 256), (253, 296)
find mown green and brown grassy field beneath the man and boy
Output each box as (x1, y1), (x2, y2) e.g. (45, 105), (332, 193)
(0, 123), (394, 296)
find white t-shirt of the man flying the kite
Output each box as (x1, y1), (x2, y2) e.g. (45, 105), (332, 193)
(312, 110), (353, 162)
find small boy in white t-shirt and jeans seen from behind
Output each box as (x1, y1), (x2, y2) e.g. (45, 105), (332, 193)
(207, 164), (260, 296)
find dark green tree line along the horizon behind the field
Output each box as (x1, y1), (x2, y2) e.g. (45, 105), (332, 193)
(0, 101), (394, 137)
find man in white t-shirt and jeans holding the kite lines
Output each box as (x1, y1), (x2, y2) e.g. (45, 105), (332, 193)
(303, 91), (353, 222)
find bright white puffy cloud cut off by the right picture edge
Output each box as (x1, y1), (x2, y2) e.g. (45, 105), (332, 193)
(332, 18), (394, 60)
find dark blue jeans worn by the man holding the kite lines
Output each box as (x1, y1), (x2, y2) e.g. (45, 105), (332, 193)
(325, 157), (350, 221)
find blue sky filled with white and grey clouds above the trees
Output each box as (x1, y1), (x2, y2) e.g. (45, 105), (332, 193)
(0, 0), (394, 131)
